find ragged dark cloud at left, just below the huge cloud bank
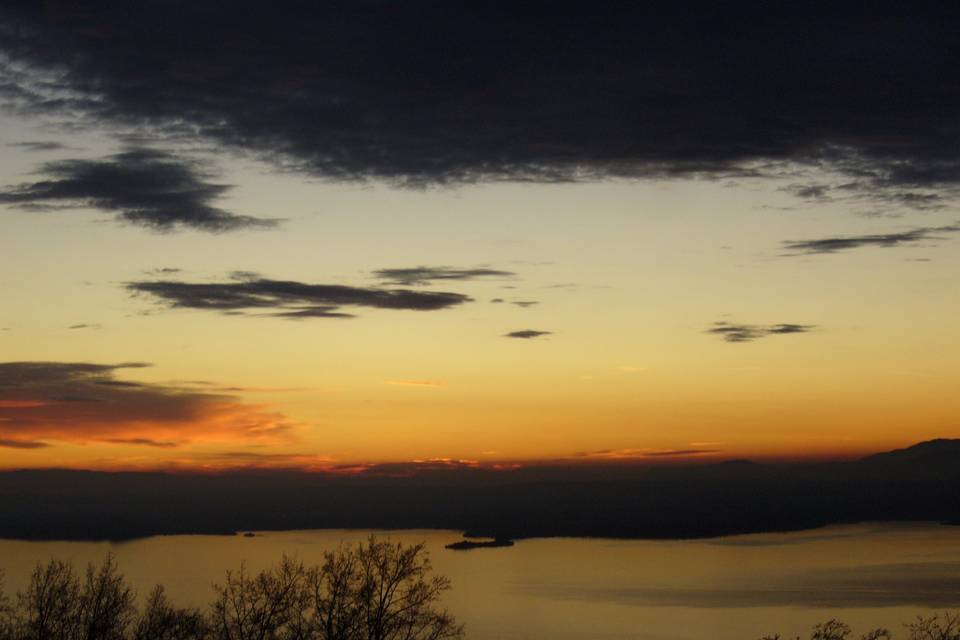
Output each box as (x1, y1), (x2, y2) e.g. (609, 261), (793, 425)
(0, 149), (276, 231)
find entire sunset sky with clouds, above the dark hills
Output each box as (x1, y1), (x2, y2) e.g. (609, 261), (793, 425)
(0, 0), (960, 472)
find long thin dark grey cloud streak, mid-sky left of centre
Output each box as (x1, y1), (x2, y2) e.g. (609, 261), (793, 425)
(126, 272), (472, 319)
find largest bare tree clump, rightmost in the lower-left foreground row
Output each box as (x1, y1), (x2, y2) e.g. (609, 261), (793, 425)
(211, 536), (463, 640)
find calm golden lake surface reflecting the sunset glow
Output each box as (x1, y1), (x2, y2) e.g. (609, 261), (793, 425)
(0, 524), (960, 640)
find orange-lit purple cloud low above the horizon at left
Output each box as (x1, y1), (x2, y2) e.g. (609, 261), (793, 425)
(0, 362), (293, 448)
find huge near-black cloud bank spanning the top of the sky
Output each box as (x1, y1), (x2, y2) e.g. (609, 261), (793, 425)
(0, 0), (960, 200)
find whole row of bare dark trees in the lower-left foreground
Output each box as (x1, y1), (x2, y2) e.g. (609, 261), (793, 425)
(0, 537), (463, 640)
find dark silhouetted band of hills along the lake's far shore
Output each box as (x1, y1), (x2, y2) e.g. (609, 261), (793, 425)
(0, 440), (960, 539)
